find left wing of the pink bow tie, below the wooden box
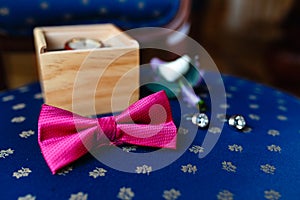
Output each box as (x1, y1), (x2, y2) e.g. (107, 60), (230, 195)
(38, 104), (97, 174)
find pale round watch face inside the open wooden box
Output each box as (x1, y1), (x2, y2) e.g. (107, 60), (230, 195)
(65, 38), (103, 50)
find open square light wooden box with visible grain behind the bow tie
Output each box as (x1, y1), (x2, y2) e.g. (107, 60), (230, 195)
(34, 24), (139, 115)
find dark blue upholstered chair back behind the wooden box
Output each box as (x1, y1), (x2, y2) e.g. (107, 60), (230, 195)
(0, 0), (180, 35)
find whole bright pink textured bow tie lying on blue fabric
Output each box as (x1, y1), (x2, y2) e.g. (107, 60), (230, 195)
(38, 91), (177, 174)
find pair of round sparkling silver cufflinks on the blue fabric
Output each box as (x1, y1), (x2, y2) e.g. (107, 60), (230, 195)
(186, 113), (247, 131)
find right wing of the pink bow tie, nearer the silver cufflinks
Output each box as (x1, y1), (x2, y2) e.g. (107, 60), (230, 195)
(115, 90), (177, 149)
